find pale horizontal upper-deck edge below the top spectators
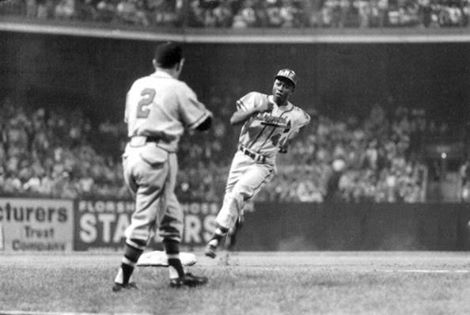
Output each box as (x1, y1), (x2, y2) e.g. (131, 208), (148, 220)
(0, 16), (470, 44)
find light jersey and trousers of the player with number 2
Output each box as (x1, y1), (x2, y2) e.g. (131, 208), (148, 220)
(123, 71), (211, 248)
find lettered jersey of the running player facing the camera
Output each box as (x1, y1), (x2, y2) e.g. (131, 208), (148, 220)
(236, 92), (310, 160)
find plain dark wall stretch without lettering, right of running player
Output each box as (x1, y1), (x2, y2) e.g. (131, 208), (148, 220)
(237, 203), (470, 251)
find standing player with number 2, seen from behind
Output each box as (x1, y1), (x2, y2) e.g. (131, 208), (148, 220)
(113, 42), (212, 292)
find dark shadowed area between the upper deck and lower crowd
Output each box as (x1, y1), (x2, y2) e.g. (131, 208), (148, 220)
(0, 32), (470, 123)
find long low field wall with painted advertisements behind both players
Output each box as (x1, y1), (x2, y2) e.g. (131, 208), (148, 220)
(0, 198), (470, 251)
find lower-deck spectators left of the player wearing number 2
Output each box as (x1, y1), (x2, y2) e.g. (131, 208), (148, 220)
(0, 98), (127, 198)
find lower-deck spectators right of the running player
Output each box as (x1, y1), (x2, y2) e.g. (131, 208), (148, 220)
(258, 105), (428, 202)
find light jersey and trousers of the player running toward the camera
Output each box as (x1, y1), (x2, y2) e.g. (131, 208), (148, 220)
(216, 92), (310, 229)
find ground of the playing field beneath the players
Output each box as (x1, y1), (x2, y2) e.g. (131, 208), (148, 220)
(0, 252), (470, 315)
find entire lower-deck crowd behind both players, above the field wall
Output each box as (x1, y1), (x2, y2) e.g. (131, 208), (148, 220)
(0, 90), (456, 202)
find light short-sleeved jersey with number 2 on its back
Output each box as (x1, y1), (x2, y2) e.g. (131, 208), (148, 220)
(124, 71), (212, 152)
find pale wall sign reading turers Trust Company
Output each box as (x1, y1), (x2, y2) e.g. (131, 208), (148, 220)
(0, 198), (73, 251)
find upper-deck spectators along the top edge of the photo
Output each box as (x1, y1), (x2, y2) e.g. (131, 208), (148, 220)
(0, 0), (470, 29)
